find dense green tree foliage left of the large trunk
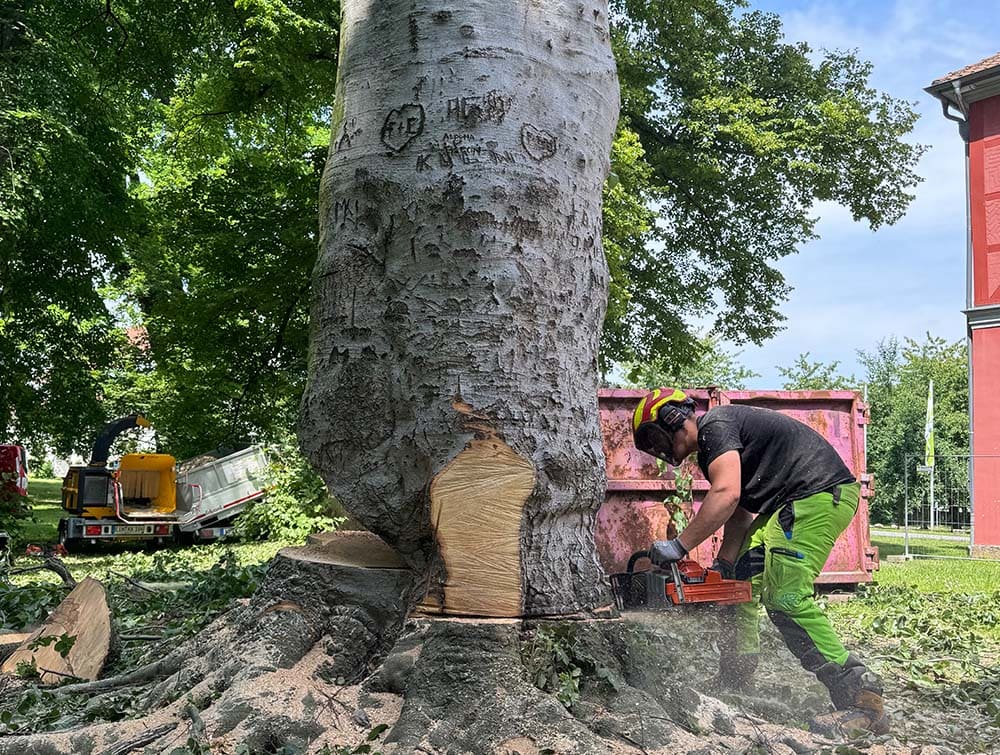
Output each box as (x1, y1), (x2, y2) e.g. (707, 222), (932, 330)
(0, 0), (339, 455)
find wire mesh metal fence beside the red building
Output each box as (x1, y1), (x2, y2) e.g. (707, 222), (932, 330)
(872, 454), (976, 558)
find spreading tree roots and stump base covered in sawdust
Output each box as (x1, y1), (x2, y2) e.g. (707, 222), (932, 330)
(0, 554), (936, 755)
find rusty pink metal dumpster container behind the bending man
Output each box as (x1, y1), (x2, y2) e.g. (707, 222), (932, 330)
(596, 388), (878, 585)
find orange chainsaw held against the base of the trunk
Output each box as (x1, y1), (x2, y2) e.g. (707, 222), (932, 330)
(610, 551), (750, 611)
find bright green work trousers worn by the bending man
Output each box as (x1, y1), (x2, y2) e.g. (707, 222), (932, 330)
(727, 482), (860, 672)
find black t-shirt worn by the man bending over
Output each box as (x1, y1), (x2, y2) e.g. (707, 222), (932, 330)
(698, 405), (855, 514)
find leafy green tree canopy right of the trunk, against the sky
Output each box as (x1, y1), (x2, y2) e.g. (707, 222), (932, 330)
(605, 0), (923, 370)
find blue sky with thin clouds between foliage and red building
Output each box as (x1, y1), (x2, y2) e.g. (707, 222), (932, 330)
(738, 0), (1000, 388)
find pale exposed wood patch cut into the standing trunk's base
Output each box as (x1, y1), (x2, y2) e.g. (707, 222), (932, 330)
(421, 438), (535, 616)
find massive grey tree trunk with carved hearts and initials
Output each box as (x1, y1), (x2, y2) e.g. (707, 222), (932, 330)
(299, 0), (618, 616)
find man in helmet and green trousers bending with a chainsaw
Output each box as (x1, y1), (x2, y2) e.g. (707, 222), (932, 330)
(632, 388), (888, 733)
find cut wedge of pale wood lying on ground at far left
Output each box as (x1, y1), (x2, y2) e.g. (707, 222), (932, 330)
(0, 577), (111, 684)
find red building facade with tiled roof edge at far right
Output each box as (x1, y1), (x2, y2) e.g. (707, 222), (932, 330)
(927, 53), (1000, 557)
